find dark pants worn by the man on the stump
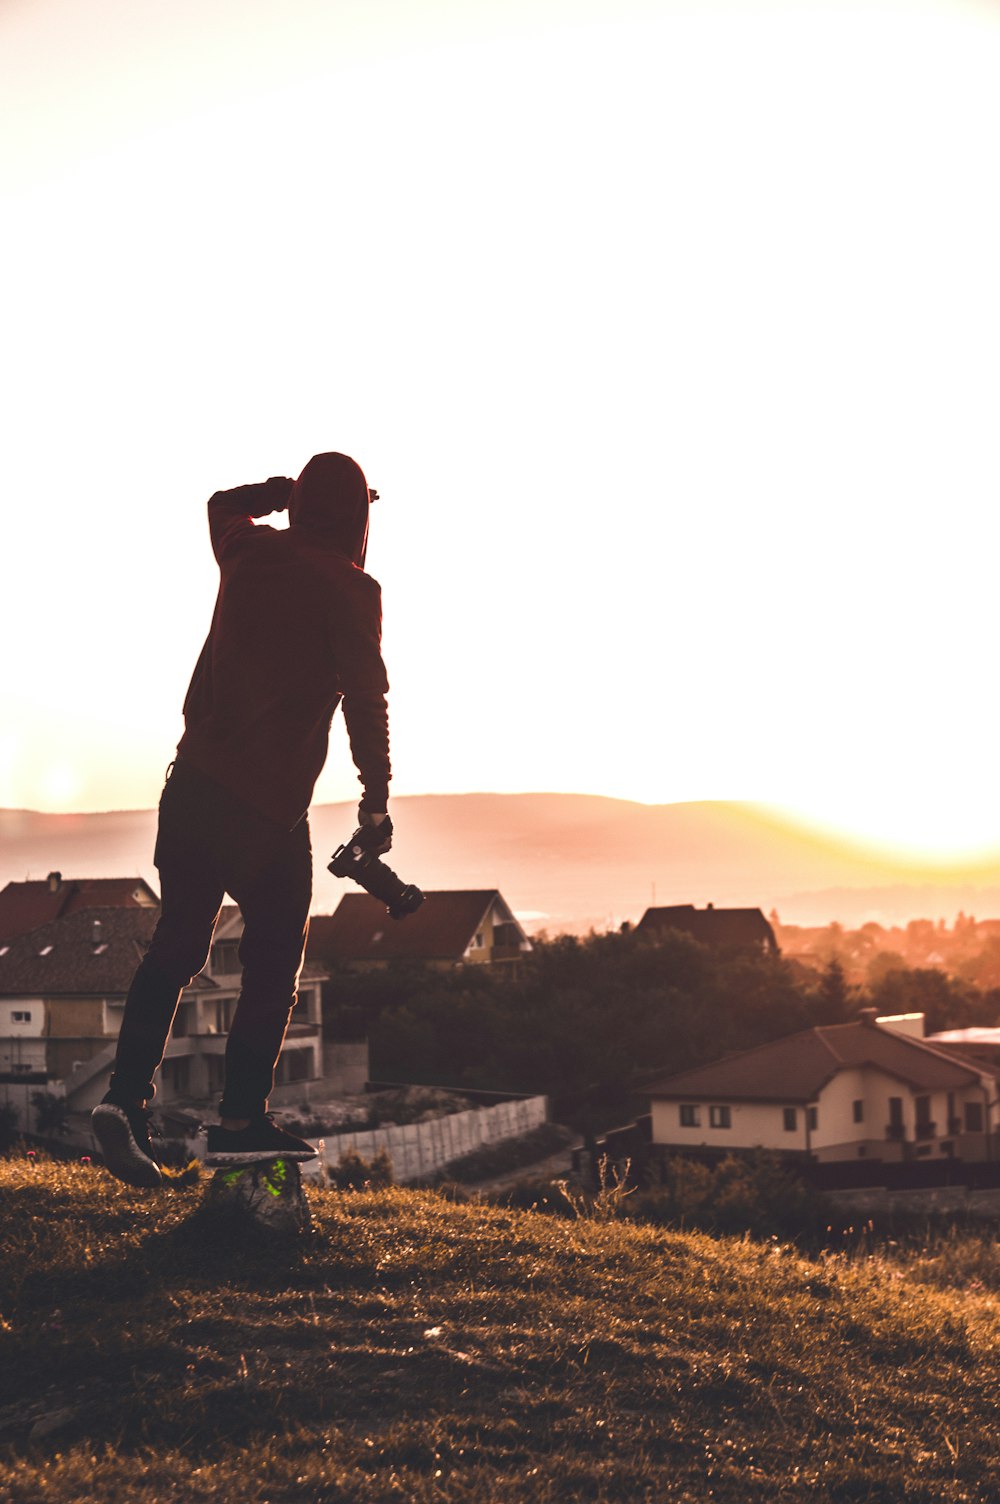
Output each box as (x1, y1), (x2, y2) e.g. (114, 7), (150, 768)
(111, 761), (313, 1117)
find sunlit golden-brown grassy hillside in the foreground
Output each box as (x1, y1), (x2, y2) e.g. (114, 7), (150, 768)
(0, 1160), (1000, 1504)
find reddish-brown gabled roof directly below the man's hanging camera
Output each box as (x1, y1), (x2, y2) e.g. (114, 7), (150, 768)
(305, 887), (513, 963)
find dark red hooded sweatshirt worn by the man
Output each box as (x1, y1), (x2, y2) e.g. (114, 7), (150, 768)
(177, 454), (389, 829)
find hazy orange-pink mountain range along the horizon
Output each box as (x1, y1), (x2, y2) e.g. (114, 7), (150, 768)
(0, 794), (1000, 934)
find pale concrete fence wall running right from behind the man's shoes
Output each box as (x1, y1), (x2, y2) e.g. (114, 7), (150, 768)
(323, 1096), (549, 1182)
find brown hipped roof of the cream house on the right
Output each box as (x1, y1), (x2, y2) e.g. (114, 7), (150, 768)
(645, 1023), (979, 1102)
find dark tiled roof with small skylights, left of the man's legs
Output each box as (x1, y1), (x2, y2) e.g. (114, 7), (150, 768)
(0, 904), (159, 997)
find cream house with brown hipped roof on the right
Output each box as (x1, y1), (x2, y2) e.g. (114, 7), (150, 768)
(647, 1008), (1000, 1161)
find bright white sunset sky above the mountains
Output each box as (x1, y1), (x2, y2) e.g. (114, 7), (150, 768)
(0, 0), (1000, 857)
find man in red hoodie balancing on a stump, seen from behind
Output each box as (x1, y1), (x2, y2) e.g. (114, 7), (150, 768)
(92, 454), (392, 1185)
